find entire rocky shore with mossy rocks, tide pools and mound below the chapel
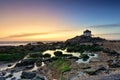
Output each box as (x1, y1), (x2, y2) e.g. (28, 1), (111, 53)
(0, 36), (120, 80)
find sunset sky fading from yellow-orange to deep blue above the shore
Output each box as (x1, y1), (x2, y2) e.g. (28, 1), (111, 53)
(0, 0), (120, 41)
